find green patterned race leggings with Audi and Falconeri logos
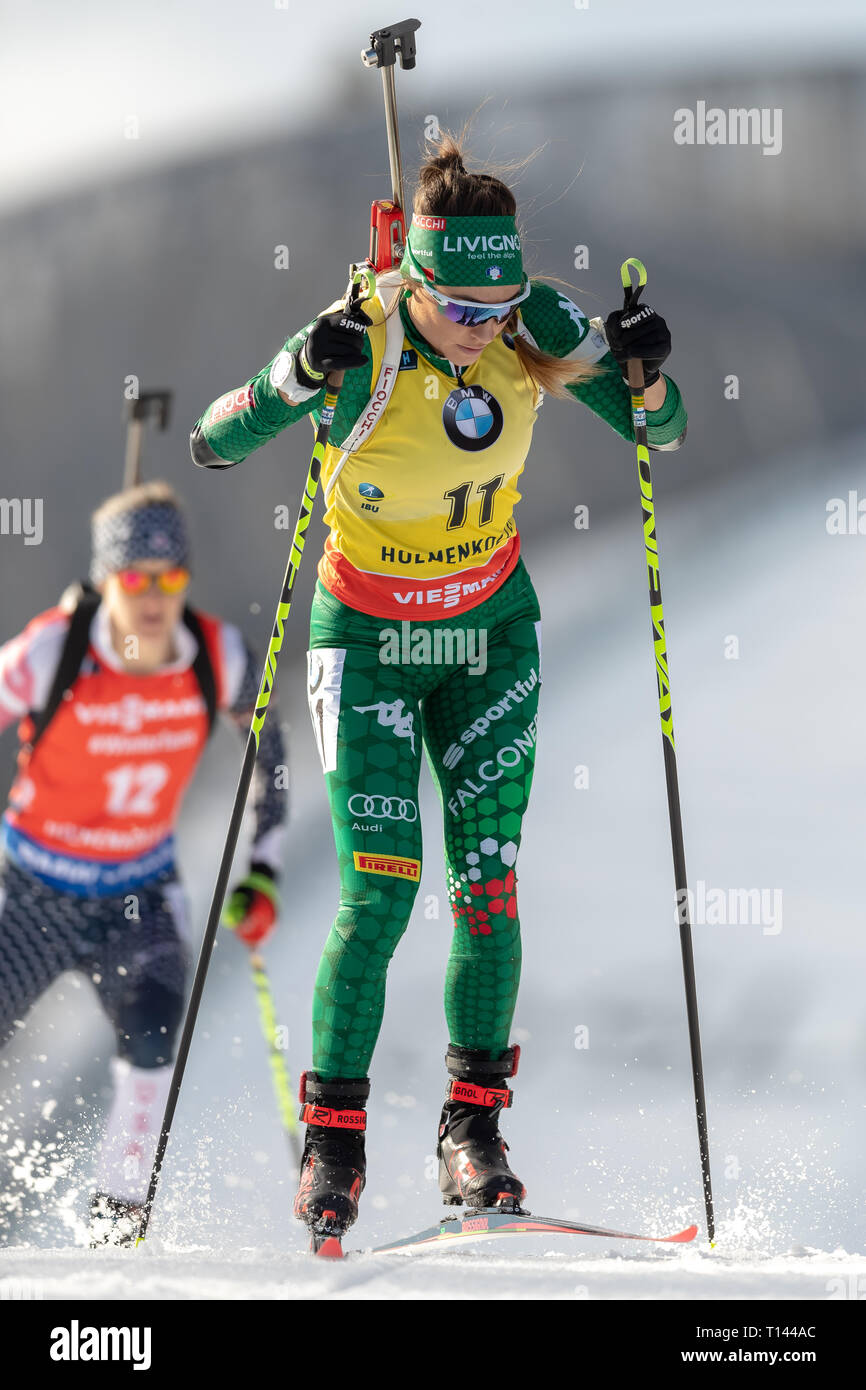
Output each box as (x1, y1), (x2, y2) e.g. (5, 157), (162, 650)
(309, 562), (539, 1077)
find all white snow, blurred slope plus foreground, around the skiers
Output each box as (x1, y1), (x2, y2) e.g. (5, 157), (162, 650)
(0, 439), (866, 1300)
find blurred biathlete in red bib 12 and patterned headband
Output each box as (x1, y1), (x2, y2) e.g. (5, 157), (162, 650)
(0, 482), (288, 1244)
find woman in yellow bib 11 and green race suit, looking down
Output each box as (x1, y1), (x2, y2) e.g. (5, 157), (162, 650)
(190, 136), (685, 1247)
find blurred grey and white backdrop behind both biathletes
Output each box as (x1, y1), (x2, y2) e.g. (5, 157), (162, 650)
(0, 0), (866, 1252)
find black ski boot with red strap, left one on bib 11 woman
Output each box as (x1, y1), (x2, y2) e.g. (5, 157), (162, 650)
(295, 1072), (370, 1258)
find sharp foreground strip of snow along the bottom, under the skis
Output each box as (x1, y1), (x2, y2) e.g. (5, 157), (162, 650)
(0, 1238), (866, 1302)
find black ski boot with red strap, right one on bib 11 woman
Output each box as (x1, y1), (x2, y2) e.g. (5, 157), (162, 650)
(436, 1043), (527, 1212)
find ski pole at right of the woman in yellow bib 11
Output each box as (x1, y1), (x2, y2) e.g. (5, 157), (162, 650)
(620, 256), (716, 1243)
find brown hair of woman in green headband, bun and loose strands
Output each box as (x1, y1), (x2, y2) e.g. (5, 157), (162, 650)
(403, 131), (598, 399)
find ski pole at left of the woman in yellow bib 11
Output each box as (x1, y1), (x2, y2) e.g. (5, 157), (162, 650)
(136, 265), (375, 1244)
